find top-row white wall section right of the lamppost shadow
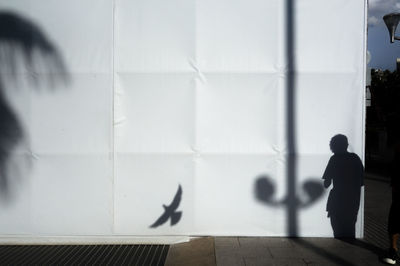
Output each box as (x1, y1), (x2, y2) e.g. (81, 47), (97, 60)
(295, 0), (366, 72)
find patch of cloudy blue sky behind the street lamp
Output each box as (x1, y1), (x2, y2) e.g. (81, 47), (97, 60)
(368, 0), (400, 70)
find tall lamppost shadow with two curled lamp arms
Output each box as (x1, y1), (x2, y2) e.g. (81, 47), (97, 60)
(255, 0), (310, 237)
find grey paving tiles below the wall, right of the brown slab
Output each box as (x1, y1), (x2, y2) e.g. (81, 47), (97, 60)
(215, 238), (380, 266)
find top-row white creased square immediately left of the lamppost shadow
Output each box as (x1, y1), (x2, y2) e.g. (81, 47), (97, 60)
(193, 0), (284, 73)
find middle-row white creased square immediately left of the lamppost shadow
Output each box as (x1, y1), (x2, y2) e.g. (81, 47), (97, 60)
(196, 73), (284, 154)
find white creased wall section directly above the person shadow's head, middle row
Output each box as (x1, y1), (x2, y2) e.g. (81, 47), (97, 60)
(296, 73), (364, 157)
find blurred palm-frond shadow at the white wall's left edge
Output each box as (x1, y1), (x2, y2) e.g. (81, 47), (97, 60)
(0, 11), (68, 199)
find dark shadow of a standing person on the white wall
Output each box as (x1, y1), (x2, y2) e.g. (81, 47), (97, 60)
(322, 134), (364, 238)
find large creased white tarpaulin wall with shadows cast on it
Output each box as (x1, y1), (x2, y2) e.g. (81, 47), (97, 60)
(0, 0), (366, 240)
